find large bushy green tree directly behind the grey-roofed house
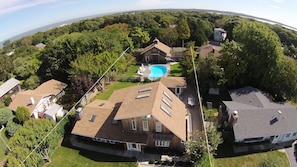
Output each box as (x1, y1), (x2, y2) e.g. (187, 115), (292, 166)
(233, 21), (283, 87)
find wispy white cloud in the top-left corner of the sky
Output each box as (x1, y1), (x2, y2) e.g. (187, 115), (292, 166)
(0, 0), (59, 15)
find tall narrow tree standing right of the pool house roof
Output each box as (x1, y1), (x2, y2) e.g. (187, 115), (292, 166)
(177, 16), (191, 48)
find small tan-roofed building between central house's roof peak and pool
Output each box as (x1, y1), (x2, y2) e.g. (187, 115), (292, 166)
(160, 77), (187, 97)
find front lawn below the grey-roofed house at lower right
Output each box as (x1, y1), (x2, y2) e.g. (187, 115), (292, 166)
(213, 151), (290, 167)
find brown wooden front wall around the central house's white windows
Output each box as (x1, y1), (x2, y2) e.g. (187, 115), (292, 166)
(121, 117), (182, 149)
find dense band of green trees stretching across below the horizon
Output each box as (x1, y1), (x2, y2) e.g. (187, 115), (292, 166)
(0, 10), (297, 99)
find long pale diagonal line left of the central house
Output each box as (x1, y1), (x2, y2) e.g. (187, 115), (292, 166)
(18, 47), (129, 166)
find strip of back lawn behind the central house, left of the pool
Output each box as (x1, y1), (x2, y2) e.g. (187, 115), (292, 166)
(96, 82), (138, 100)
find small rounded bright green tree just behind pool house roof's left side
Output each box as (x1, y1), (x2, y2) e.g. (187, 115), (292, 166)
(130, 27), (150, 48)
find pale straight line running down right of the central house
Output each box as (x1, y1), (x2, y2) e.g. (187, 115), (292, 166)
(190, 47), (212, 167)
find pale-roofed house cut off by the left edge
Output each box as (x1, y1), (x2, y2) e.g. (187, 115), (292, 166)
(0, 78), (21, 101)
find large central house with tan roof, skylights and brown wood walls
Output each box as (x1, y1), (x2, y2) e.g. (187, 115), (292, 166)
(71, 82), (189, 151)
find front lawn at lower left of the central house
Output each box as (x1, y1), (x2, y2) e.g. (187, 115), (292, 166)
(45, 146), (137, 167)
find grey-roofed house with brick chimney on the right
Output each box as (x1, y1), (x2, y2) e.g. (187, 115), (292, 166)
(222, 87), (297, 144)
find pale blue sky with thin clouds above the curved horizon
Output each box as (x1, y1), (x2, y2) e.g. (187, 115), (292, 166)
(0, 0), (297, 42)
